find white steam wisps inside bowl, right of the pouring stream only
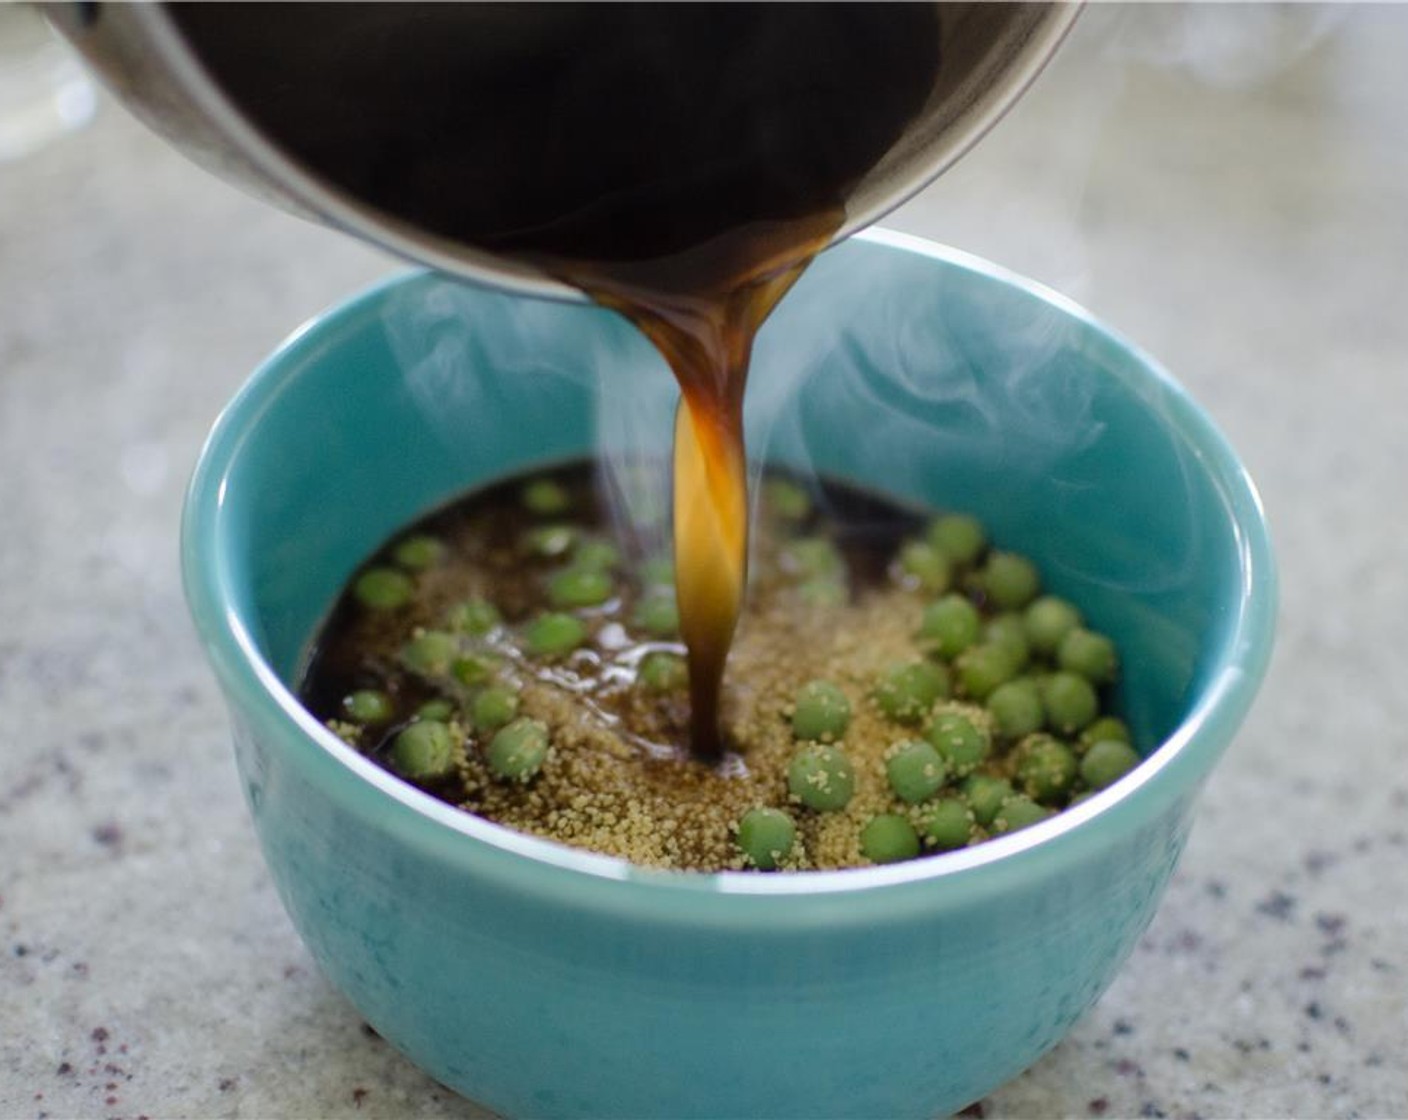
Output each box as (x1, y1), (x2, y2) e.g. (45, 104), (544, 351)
(748, 238), (1102, 515)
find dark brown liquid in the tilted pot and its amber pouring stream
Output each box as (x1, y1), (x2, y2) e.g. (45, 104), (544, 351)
(173, 3), (941, 758)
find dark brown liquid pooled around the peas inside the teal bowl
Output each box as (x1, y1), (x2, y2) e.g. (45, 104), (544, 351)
(298, 462), (929, 777)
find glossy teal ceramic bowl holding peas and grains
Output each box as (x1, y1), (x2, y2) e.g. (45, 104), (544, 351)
(183, 234), (1276, 1117)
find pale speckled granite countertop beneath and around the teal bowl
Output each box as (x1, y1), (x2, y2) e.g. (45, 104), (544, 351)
(0, 6), (1408, 1117)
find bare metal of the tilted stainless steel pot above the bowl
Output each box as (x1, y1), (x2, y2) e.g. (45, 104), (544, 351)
(44, 3), (1079, 297)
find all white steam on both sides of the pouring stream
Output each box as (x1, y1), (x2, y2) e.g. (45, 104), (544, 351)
(384, 233), (1102, 577)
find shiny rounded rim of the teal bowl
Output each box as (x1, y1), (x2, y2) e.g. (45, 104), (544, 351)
(182, 228), (1277, 904)
